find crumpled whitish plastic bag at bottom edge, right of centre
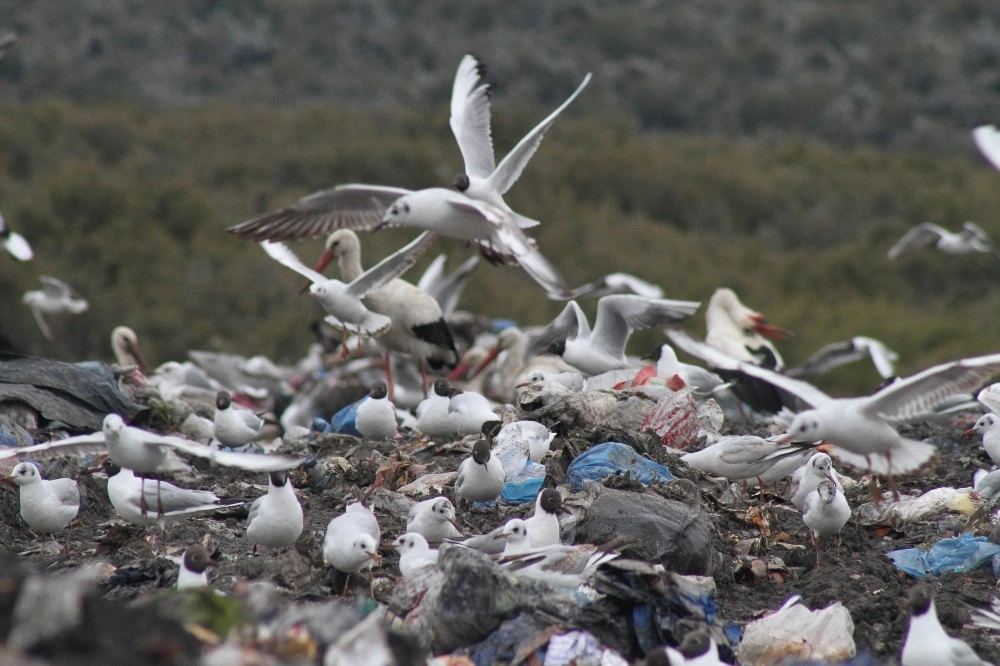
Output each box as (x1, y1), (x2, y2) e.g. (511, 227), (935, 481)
(737, 601), (857, 666)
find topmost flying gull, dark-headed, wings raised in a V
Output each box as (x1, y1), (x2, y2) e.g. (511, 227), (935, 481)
(448, 55), (590, 229)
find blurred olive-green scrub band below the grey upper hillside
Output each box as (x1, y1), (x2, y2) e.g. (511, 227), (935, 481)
(0, 101), (1000, 391)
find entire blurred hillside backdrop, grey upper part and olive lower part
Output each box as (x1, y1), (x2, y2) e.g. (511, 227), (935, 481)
(0, 0), (1000, 391)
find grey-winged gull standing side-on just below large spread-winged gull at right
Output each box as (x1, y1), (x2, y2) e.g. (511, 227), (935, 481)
(681, 435), (813, 482)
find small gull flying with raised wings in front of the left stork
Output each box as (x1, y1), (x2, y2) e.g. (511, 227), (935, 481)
(260, 232), (434, 336)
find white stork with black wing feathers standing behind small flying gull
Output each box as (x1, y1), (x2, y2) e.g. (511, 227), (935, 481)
(315, 229), (458, 386)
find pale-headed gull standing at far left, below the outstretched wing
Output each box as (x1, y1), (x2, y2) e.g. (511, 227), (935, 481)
(10, 462), (80, 547)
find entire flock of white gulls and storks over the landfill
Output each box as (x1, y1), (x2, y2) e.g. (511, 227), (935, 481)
(0, 56), (1000, 666)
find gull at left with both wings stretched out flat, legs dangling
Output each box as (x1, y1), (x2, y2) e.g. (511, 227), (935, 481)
(0, 414), (304, 515)
